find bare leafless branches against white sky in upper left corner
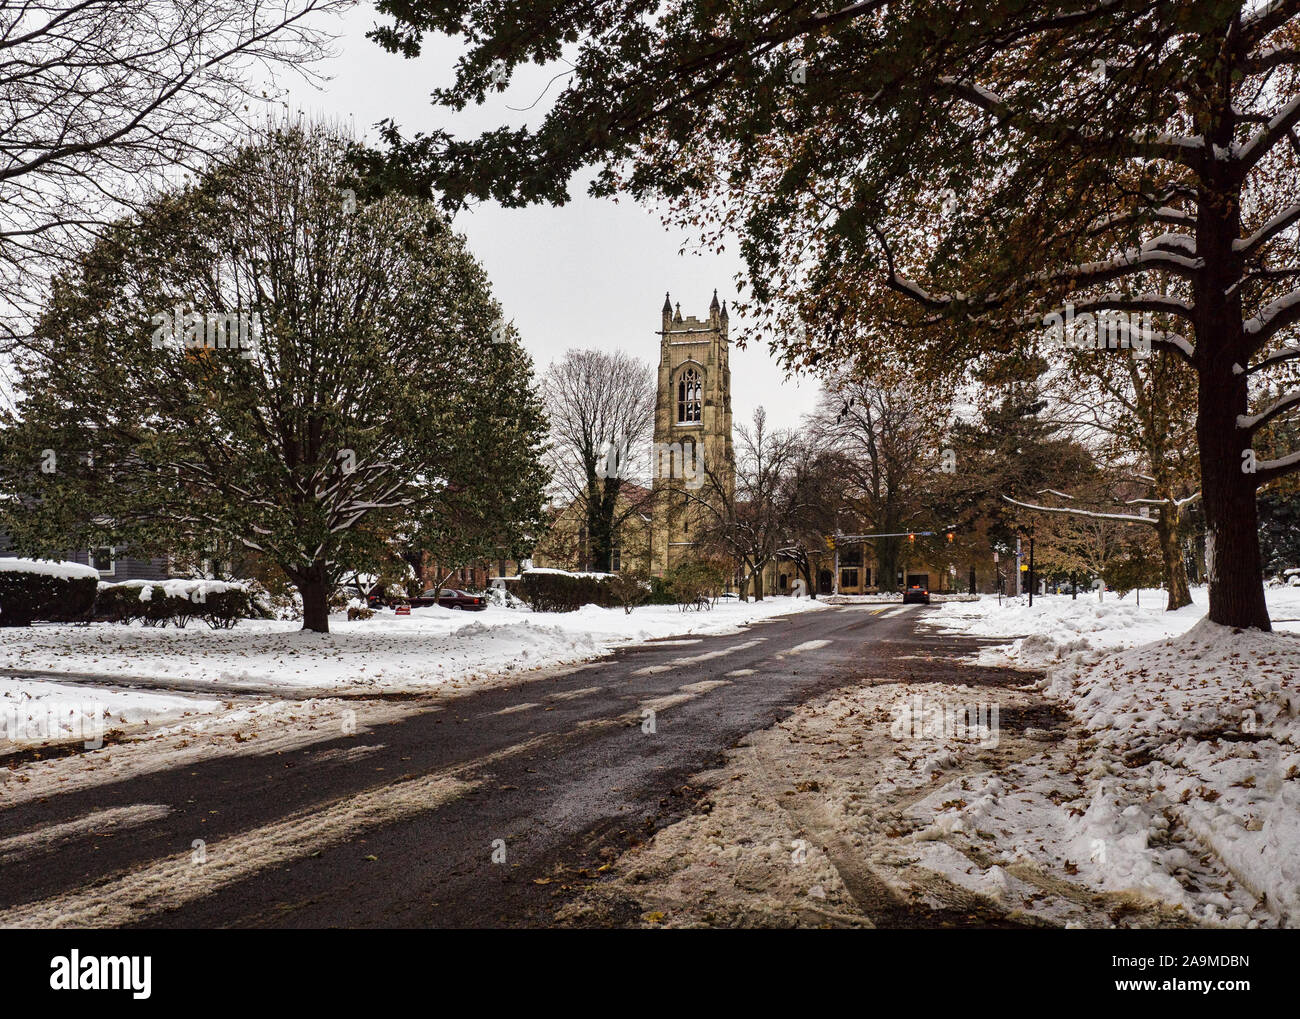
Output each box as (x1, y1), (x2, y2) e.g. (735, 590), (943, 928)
(0, 0), (351, 361)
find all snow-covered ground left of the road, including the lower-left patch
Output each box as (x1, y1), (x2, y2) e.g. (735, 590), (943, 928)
(0, 598), (822, 742)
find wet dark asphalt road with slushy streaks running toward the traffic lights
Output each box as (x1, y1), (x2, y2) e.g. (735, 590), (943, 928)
(0, 606), (977, 927)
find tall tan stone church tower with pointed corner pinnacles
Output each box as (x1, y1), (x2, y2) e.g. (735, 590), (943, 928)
(650, 290), (735, 576)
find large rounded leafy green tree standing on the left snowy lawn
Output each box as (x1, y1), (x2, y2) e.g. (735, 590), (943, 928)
(0, 126), (545, 632)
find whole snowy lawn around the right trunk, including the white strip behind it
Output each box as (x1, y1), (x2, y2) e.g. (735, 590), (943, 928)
(930, 587), (1300, 927)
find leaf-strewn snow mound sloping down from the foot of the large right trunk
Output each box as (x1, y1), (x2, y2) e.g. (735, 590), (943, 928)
(1048, 620), (1300, 925)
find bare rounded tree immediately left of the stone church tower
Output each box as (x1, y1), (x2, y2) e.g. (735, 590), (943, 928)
(542, 350), (655, 571)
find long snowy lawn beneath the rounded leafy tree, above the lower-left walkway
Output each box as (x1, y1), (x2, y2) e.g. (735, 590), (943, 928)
(0, 598), (822, 695)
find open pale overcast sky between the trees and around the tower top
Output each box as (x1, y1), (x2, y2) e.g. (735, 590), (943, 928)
(282, 4), (818, 426)
